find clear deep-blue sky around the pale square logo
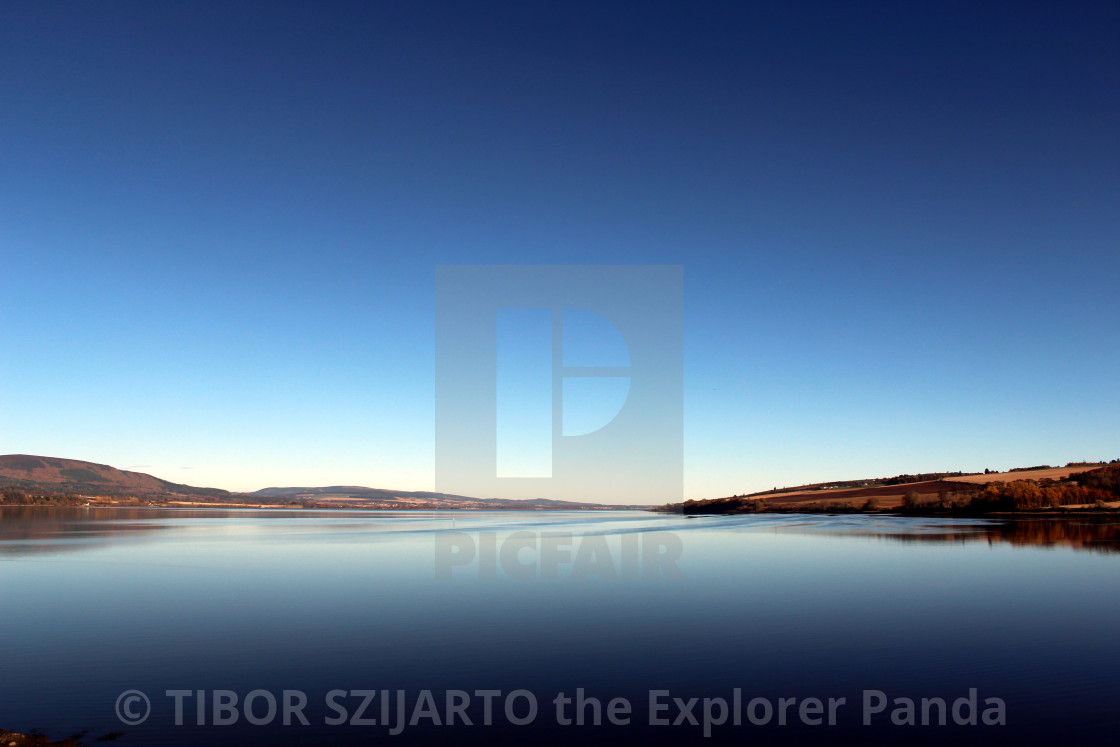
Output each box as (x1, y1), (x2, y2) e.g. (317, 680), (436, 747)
(0, 0), (1120, 498)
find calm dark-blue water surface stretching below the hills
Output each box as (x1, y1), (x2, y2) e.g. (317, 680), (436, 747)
(0, 508), (1120, 745)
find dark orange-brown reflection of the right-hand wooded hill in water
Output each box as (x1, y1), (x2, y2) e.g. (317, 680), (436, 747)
(822, 516), (1120, 552)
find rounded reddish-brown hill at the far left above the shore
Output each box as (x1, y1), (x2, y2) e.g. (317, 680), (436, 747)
(0, 454), (232, 499)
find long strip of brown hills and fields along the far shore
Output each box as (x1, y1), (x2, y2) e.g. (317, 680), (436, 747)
(0, 455), (1120, 516)
